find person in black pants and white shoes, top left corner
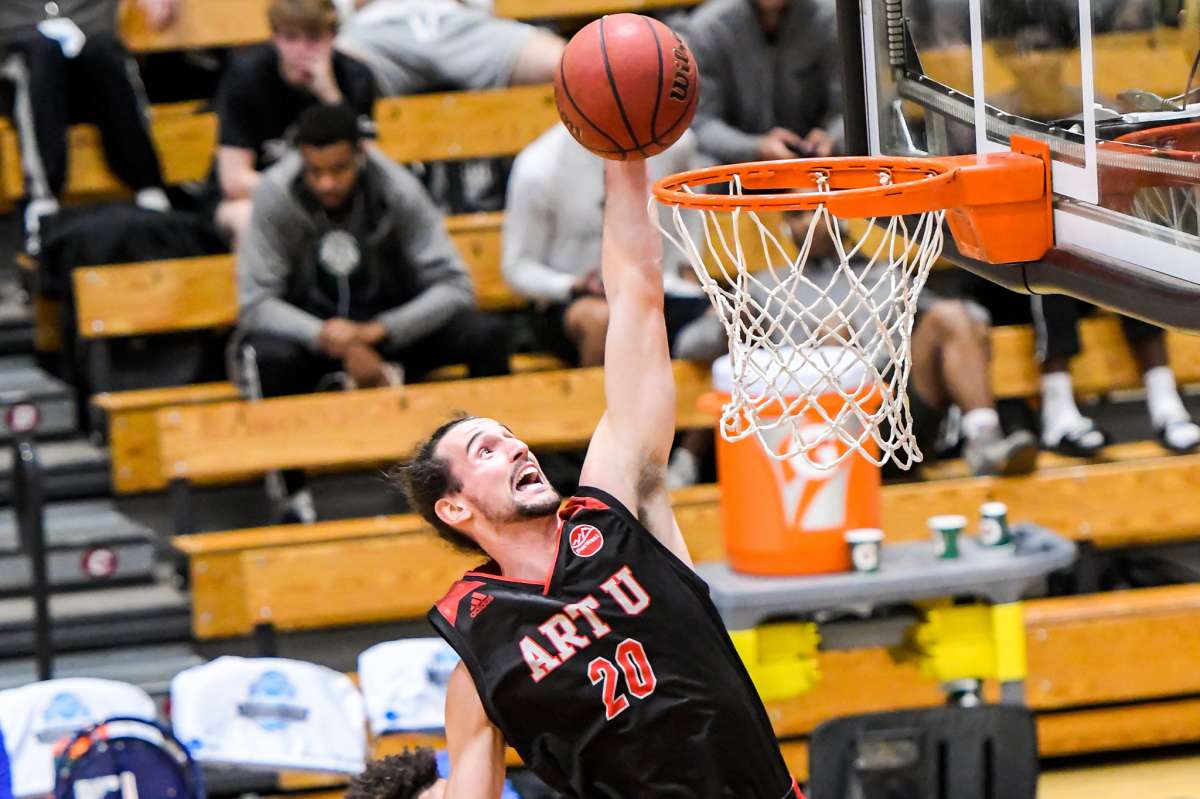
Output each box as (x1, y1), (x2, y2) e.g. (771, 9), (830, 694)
(0, 0), (178, 256)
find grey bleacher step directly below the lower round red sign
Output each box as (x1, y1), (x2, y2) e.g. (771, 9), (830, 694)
(0, 566), (191, 657)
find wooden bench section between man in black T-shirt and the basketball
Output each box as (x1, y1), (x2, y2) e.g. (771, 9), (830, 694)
(376, 84), (558, 162)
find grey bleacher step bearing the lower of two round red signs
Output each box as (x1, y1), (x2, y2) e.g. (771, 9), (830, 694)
(0, 499), (155, 594)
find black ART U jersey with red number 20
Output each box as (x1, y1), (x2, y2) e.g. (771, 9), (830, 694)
(430, 488), (799, 799)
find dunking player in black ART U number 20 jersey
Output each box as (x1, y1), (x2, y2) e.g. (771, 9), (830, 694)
(400, 161), (800, 799)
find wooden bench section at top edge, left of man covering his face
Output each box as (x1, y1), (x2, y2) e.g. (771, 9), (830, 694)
(120, 0), (271, 53)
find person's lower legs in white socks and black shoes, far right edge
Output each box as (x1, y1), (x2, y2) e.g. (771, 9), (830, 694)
(1032, 294), (1200, 457)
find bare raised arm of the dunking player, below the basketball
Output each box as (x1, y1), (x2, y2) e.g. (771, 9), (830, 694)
(581, 161), (686, 559)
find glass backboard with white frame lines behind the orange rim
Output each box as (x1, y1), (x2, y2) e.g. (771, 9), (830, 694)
(839, 0), (1200, 328)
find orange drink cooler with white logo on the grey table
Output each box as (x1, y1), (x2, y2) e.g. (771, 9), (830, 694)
(702, 356), (880, 576)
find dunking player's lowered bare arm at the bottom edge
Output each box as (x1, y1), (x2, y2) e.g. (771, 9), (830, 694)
(445, 663), (504, 799)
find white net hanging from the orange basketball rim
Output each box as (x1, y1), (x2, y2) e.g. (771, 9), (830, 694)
(662, 172), (946, 469)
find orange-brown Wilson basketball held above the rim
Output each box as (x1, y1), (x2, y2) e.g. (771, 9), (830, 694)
(554, 14), (700, 161)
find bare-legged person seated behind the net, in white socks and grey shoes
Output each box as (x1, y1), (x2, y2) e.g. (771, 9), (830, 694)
(785, 211), (1038, 475)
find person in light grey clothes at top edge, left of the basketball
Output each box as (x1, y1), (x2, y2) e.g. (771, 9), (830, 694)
(337, 0), (563, 97)
